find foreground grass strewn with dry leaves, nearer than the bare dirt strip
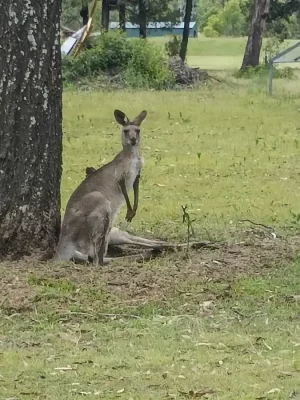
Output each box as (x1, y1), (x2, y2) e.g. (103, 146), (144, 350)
(0, 256), (300, 400)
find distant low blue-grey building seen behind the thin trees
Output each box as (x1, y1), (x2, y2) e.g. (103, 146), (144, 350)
(109, 21), (198, 37)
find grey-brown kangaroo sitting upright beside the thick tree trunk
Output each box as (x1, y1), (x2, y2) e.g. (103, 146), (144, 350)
(54, 110), (147, 266)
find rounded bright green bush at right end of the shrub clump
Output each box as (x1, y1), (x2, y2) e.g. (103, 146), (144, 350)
(124, 39), (174, 90)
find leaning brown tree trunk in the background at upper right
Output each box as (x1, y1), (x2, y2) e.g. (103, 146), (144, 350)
(241, 0), (270, 70)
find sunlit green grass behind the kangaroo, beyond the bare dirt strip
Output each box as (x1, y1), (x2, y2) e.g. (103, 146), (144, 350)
(62, 88), (300, 238)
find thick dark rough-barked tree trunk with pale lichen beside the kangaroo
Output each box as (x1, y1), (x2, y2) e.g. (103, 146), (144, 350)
(0, 0), (62, 259)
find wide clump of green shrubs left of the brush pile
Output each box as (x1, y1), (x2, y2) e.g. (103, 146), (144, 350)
(62, 32), (174, 89)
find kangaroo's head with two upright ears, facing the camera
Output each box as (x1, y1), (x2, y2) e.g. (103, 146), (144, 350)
(114, 110), (147, 147)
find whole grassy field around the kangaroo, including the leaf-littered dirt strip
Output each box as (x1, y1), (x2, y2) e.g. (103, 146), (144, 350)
(0, 39), (300, 400)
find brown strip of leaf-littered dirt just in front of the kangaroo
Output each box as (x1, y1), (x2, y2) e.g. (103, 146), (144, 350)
(0, 230), (300, 314)
